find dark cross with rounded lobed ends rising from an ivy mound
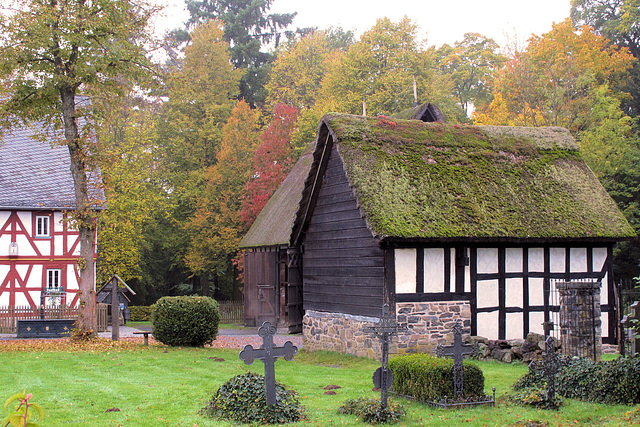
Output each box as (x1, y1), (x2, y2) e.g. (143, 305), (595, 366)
(240, 322), (298, 405)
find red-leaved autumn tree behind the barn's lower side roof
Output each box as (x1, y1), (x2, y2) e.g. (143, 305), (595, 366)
(240, 103), (298, 228)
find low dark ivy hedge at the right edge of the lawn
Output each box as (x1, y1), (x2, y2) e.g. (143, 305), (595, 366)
(514, 357), (640, 405)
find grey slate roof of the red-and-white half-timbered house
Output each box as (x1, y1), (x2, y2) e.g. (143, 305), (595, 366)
(0, 126), (104, 210)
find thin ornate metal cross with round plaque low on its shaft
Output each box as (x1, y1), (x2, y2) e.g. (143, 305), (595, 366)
(362, 304), (407, 408)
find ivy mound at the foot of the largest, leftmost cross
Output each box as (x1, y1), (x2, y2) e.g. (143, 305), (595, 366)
(202, 372), (304, 424)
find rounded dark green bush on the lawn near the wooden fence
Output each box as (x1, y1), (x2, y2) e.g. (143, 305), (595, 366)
(151, 296), (220, 347)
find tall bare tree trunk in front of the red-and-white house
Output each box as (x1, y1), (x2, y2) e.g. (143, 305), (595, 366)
(60, 88), (98, 336)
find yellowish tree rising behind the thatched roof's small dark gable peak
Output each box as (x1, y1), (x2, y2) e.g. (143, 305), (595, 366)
(437, 33), (506, 114)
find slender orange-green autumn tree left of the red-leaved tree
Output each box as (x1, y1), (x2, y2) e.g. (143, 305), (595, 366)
(186, 101), (258, 297)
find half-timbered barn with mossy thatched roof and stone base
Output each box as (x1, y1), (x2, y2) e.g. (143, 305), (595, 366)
(245, 110), (634, 355)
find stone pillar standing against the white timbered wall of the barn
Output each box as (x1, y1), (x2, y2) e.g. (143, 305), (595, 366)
(556, 281), (602, 360)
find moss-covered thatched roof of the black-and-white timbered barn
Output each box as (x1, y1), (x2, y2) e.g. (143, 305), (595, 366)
(308, 113), (634, 242)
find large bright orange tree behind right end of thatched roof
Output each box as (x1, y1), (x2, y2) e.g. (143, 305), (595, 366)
(476, 20), (633, 131)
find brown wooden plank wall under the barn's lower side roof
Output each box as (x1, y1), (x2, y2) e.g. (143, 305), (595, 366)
(244, 248), (280, 326)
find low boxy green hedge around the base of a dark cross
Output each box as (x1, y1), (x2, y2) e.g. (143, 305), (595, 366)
(389, 354), (485, 402)
